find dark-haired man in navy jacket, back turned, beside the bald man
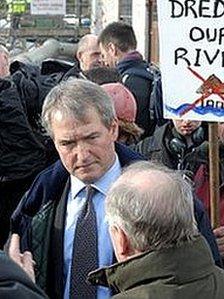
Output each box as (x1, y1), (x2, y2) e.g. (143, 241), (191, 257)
(98, 22), (162, 139)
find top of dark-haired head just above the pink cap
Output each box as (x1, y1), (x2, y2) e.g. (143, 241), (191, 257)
(83, 67), (121, 85)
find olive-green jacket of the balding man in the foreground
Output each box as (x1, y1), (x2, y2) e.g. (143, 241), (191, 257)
(89, 236), (224, 299)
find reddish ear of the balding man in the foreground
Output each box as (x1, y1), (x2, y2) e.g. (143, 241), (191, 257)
(110, 226), (132, 262)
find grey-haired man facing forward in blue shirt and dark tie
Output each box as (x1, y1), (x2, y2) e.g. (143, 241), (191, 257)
(7, 79), (141, 298)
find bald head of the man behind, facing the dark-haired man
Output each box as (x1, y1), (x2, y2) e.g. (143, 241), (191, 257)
(76, 34), (101, 71)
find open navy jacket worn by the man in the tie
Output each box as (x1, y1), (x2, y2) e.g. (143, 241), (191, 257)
(9, 144), (143, 298)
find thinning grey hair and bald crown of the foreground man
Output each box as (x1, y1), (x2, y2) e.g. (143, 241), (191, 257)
(106, 161), (198, 252)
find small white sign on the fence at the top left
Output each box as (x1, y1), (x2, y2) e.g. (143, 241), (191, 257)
(30, 0), (66, 15)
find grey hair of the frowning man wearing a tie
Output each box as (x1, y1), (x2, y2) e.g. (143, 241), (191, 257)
(42, 78), (116, 138)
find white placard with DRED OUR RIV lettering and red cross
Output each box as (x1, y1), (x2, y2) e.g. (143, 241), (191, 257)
(157, 0), (224, 121)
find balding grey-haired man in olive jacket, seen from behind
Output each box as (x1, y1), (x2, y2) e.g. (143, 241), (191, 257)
(89, 162), (224, 299)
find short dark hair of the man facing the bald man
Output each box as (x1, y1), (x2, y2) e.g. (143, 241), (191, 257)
(98, 22), (137, 52)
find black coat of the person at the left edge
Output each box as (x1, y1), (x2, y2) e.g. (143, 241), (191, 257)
(0, 61), (58, 249)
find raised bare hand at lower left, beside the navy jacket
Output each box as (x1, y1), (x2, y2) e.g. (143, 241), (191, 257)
(8, 234), (35, 282)
